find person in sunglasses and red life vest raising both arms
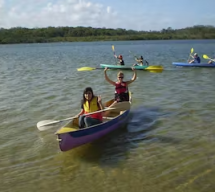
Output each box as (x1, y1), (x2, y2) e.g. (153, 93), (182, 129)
(104, 67), (137, 106)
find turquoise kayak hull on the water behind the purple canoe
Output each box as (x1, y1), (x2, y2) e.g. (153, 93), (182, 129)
(100, 64), (163, 71)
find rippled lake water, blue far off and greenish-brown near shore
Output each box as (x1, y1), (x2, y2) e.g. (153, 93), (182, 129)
(0, 40), (215, 192)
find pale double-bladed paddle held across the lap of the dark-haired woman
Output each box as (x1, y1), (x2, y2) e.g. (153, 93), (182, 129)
(37, 102), (130, 131)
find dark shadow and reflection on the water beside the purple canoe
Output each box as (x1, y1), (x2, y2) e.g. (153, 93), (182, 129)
(55, 107), (176, 167)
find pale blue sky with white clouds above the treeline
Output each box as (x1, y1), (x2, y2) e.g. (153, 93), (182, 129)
(0, 0), (215, 31)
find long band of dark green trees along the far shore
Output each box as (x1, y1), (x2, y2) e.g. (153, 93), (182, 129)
(0, 25), (215, 44)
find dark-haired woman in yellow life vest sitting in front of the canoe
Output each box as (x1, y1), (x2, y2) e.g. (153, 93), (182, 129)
(77, 87), (104, 128)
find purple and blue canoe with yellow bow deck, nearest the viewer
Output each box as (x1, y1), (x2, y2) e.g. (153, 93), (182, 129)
(55, 100), (130, 151)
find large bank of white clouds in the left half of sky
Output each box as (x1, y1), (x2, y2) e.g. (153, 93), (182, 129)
(0, 0), (117, 28)
